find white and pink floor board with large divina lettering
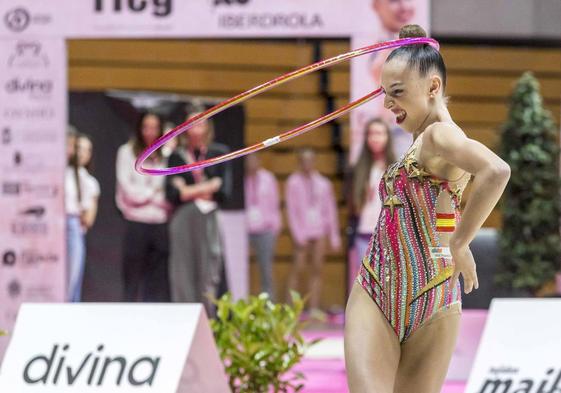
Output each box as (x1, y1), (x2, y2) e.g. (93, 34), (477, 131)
(0, 303), (229, 393)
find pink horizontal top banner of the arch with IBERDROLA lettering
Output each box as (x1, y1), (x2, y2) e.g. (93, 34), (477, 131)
(0, 0), (360, 38)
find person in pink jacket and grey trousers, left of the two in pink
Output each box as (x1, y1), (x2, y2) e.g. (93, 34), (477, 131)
(244, 154), (281, 299)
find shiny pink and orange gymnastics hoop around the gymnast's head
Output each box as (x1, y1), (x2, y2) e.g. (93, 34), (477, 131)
(135, 37), (440, 175)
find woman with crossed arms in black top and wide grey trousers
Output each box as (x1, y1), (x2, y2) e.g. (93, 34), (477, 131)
(166, 106), (232, 315)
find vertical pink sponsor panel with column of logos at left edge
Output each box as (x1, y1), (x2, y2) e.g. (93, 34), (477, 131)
(0, 38), (67, 360)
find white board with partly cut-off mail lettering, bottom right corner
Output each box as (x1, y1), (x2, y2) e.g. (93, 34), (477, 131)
(466, 299), (561, 393)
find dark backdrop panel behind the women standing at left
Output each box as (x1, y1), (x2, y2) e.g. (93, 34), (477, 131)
(69, 90), (245, 301)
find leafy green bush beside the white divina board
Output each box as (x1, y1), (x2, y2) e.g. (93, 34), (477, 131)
(211, 292), (317, 393)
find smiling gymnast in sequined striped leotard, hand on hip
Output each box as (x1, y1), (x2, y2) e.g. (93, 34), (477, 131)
(345, 25), (510, 393)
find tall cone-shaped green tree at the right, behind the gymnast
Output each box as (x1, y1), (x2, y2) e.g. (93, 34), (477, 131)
(496, 72), (561, 294)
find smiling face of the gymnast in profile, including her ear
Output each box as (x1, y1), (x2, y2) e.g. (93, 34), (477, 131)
(382, 58), (442, 132)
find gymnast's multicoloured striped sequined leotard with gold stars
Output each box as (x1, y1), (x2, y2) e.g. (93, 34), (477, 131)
(357, 135), (469, 343)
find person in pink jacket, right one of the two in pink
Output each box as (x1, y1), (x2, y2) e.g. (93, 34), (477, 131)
(286, 148), (341, 313)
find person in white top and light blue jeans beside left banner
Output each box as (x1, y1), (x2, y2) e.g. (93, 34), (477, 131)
(65, 127), (100, 302)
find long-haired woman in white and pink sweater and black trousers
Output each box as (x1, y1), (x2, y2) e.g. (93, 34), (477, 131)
(115, 112), (170, 302)
